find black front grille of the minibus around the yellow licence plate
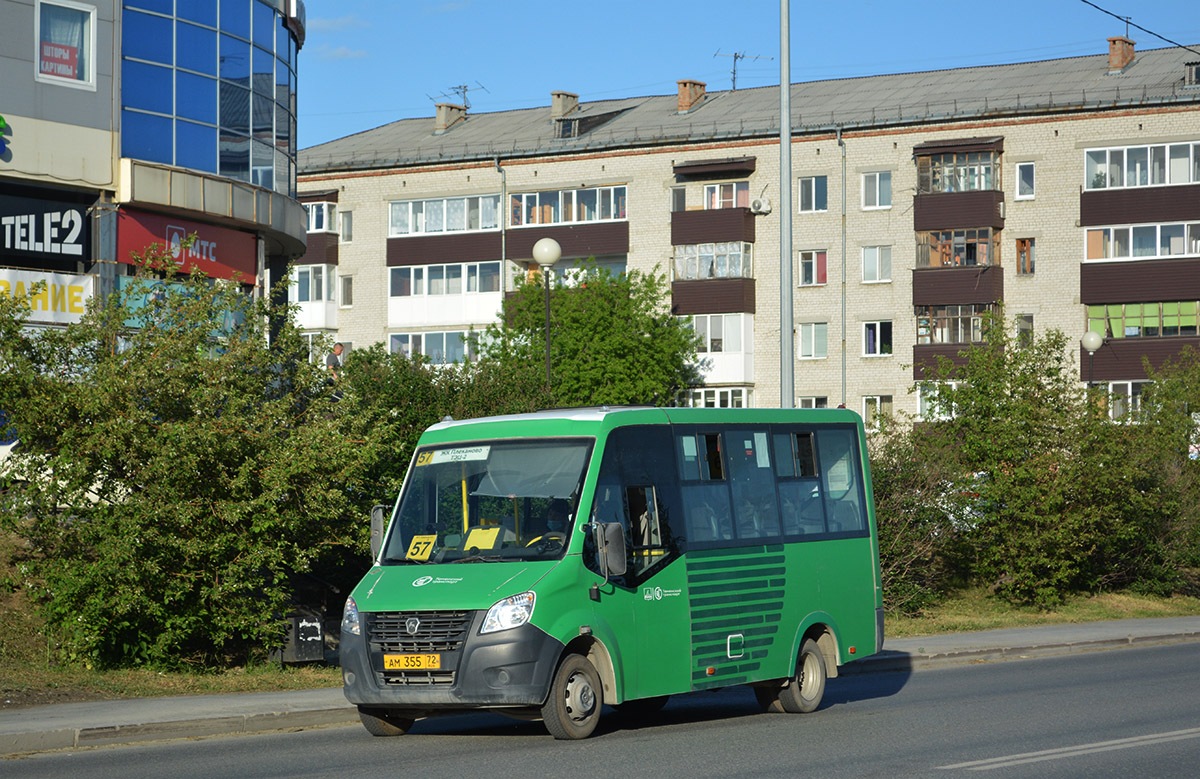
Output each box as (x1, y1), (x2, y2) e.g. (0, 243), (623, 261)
(366, 611), (474, 687)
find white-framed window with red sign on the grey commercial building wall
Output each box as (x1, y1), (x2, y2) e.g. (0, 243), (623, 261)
(34, 0), (96, 90)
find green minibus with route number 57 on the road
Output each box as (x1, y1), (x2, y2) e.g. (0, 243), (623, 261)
(341, 407), (883, 738)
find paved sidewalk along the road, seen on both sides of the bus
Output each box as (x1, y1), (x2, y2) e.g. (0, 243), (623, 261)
(0, 617), (1200, 755)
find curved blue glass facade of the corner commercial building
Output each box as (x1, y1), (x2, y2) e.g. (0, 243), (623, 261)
(121, 0), (296, 197)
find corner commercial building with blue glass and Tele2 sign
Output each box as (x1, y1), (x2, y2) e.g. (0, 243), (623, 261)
(0, 0), (306, 326)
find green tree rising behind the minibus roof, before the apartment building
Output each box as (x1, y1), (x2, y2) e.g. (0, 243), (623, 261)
(479, 266), (698, 407)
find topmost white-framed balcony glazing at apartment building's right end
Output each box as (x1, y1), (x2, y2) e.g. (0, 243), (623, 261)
(1084, 140), (1200, 190)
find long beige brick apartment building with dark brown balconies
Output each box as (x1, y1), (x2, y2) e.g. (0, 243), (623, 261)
(292, 37), (1200, 419)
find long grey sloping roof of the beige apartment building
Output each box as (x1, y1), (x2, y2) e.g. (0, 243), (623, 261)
(299, 47), (1200, 175)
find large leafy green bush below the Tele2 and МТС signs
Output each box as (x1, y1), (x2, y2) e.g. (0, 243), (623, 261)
(0, 250), (366, 665)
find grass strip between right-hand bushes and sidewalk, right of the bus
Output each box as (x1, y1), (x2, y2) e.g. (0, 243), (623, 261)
(886, 588), (1200, 639)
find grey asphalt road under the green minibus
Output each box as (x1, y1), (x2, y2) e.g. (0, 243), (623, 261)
(9, 642), (1200, 779)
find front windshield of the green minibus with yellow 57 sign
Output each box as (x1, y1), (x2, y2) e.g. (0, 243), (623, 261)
(380, 439), (592, 564)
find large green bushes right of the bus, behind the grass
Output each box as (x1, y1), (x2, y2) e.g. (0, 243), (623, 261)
(876, 317), (1196, 606)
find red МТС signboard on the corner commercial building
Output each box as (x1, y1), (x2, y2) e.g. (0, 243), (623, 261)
(116, 209), (258, 284)
